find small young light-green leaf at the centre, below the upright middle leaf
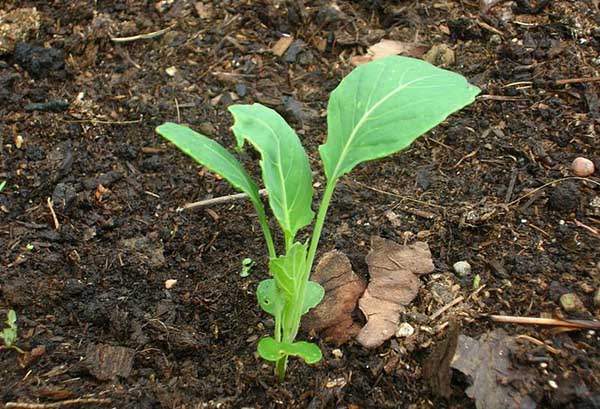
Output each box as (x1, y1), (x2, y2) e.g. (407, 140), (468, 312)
(269, 242), (307, 302)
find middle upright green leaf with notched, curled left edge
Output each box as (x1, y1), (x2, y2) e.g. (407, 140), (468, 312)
(229, 104), (314, 240)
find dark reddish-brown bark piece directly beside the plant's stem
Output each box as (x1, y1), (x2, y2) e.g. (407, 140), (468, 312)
(302, 250), (365, 344)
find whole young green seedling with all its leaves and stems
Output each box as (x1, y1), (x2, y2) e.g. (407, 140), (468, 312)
(156, 56), (480, 379)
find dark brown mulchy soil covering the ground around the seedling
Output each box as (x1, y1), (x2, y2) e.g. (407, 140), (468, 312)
(0, 0), (600, 408)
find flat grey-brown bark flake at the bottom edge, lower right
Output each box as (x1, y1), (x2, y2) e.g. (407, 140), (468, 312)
(450, 330), (537, 409)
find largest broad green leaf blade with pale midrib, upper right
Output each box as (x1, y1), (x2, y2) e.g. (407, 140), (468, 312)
(319, 56), (480, 180)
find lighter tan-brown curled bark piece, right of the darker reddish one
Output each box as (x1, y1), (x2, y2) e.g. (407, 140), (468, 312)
(356, 237), (434, 348)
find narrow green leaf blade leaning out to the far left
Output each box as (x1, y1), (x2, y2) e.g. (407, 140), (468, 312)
(156, 122), (262, 207)
